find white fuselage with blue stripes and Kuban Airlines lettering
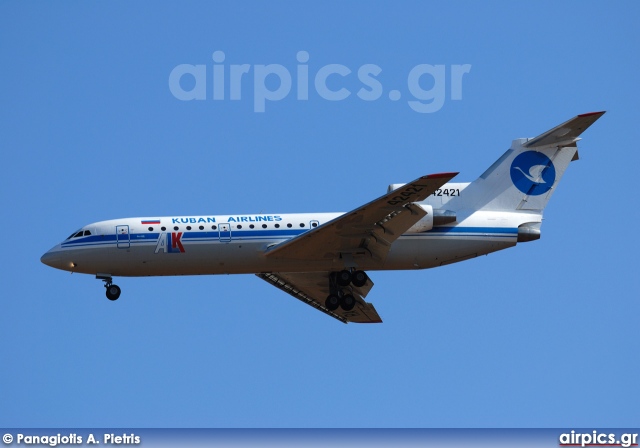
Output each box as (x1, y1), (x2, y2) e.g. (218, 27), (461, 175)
(42, 211), (541, 276)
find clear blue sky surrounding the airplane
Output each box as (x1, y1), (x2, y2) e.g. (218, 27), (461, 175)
(0, 1), (640, 427)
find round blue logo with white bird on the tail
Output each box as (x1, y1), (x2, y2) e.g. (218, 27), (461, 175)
(511, 151), (556, 196)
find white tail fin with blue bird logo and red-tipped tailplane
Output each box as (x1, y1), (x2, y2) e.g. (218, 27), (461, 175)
(447, 112), (604, 211)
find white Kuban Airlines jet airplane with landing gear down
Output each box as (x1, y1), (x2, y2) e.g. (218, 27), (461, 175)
(41, 111), (605, 323)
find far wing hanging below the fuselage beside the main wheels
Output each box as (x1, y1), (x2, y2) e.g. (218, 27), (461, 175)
(256, 272), (382, 324)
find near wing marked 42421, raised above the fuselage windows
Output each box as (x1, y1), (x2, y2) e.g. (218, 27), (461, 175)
(265, 173), (458, 267)
